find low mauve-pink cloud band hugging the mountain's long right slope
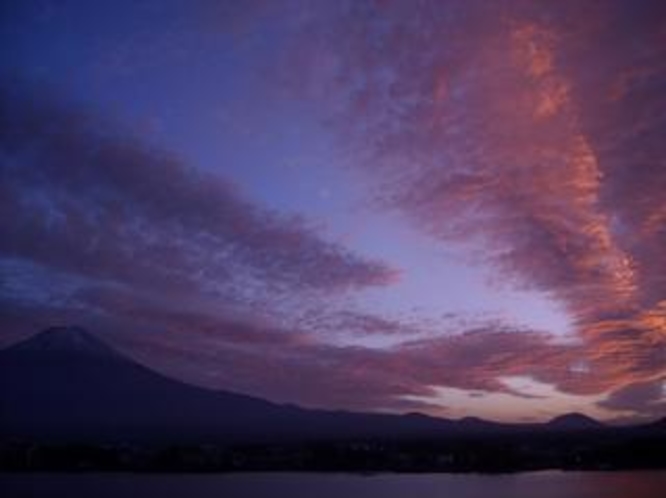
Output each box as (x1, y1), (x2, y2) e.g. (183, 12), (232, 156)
(110, 310), (568, 414)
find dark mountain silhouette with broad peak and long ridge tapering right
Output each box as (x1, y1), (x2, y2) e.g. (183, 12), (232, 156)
(0, 327), (616, 442)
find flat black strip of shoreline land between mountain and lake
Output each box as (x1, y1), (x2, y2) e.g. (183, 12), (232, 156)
(0, 428), (666, 473)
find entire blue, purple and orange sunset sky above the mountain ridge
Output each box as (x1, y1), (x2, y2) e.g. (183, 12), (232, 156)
(0, 0), (666, 422)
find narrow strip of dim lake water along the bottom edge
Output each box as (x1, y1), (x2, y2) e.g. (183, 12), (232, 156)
(0, 471), (666, 498)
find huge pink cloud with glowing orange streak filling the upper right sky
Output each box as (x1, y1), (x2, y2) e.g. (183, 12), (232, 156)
(270, 0), (666, 414)
